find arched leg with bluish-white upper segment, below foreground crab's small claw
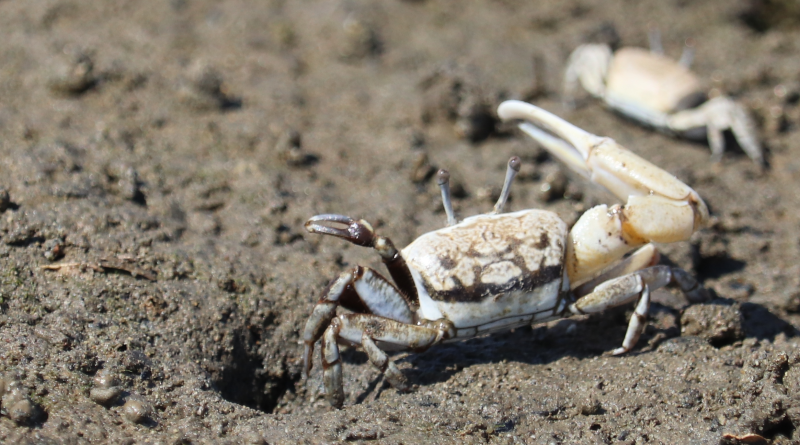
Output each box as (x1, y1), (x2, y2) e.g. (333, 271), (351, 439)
(303, 266), (414, 376)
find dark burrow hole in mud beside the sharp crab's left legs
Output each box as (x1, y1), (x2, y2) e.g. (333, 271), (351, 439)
(213, 329), (300, 413)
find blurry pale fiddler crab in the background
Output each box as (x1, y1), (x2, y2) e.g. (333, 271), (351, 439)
(564, 32), (764, 166)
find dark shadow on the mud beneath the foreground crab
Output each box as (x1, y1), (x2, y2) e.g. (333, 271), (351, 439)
(354, 298), (800, 403)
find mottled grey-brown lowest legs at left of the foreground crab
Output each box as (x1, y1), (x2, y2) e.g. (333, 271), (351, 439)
(322, 314), (446, 408)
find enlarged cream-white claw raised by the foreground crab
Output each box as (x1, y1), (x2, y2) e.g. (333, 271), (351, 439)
(497, 101), (708, 284)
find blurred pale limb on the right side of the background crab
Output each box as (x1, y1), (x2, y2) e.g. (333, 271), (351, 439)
(667, 96), (764, 165)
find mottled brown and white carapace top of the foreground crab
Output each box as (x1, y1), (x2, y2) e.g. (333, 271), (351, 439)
(403, 210), (567, 302)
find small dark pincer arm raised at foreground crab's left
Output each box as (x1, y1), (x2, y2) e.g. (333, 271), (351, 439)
(306, 214), (419, 304)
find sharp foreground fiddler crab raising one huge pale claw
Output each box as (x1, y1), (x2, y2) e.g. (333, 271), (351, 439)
(303, 101), (708, 407)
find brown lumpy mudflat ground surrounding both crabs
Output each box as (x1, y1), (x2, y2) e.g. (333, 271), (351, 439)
(0, 0), (800, 445)
